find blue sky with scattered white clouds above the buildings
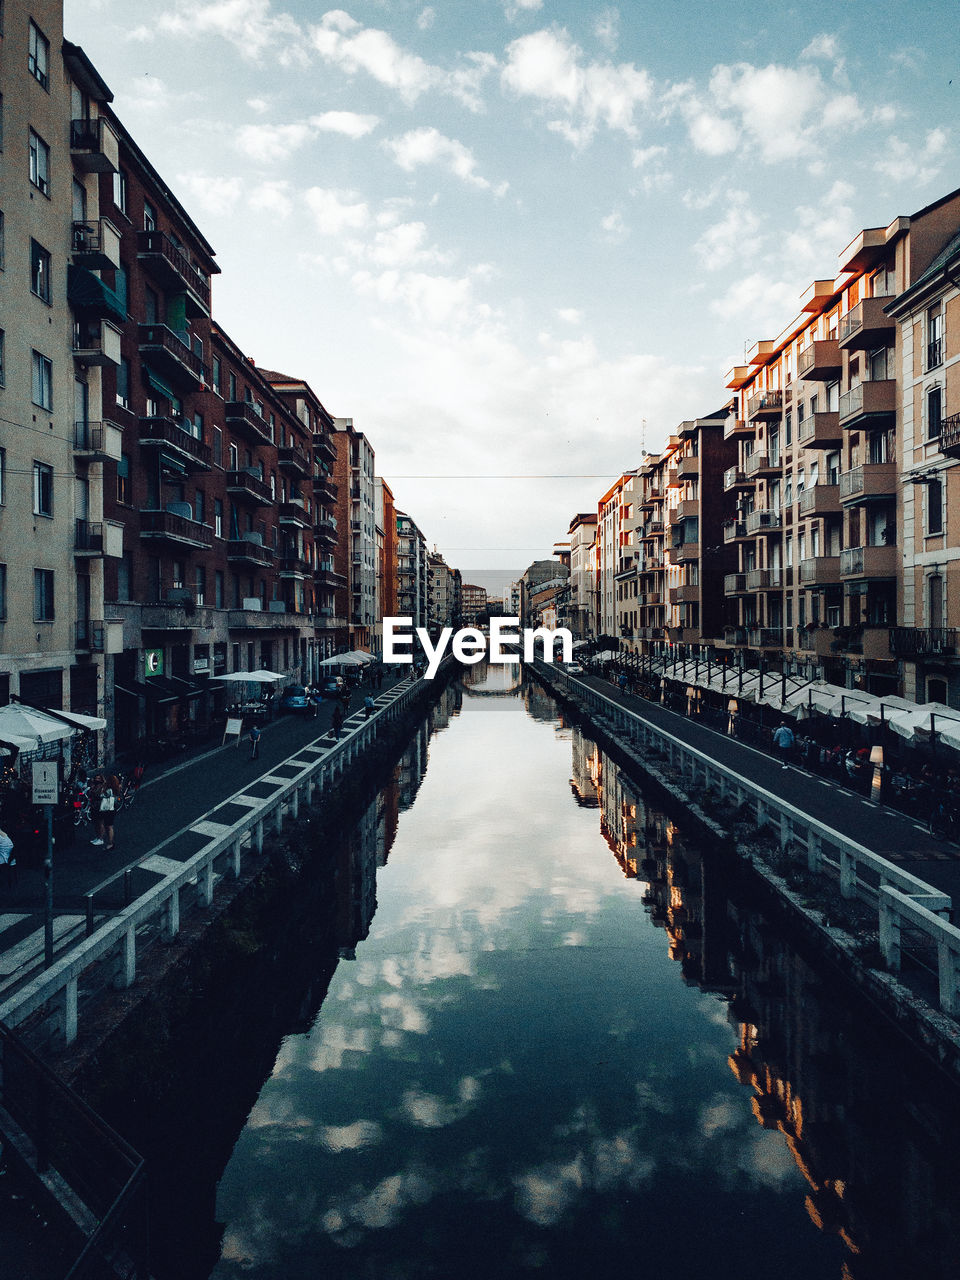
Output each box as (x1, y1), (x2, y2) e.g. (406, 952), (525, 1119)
(65, 0), (960, 573)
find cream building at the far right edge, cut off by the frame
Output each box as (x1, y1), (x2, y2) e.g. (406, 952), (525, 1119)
(886, 234), (960, 707)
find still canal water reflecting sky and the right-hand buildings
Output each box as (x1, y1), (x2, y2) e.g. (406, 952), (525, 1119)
(138, 667), (960, 1280)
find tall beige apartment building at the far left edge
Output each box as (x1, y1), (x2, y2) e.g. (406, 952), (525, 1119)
(0, 0), (120, 714)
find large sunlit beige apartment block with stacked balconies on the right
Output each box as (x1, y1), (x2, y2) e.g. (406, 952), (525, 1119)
(724, 192), (960, 692)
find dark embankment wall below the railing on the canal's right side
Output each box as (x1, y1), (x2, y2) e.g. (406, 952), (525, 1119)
(535, 664), (960, 1083)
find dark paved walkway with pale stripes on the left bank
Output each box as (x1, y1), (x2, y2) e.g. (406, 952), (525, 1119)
(0, 668), (408, 1000)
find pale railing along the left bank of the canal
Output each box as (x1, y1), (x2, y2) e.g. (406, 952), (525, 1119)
(0, 657), (435, 1044)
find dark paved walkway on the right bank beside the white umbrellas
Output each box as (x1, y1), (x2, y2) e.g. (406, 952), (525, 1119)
(576, 676), (960, 905)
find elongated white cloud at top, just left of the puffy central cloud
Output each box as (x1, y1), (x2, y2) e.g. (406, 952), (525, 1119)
(310, 9), (495, 111)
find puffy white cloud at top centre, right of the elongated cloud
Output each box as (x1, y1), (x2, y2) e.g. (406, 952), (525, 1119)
(500, 28), (653, 146)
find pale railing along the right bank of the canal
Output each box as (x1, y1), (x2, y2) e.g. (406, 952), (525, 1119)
(534, 662), (960, 1016)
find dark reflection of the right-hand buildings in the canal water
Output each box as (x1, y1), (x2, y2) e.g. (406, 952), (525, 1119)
(571, 728), (960, 1280)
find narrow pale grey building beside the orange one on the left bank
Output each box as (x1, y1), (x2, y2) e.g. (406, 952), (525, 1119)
(333, 417), (379, 650)
